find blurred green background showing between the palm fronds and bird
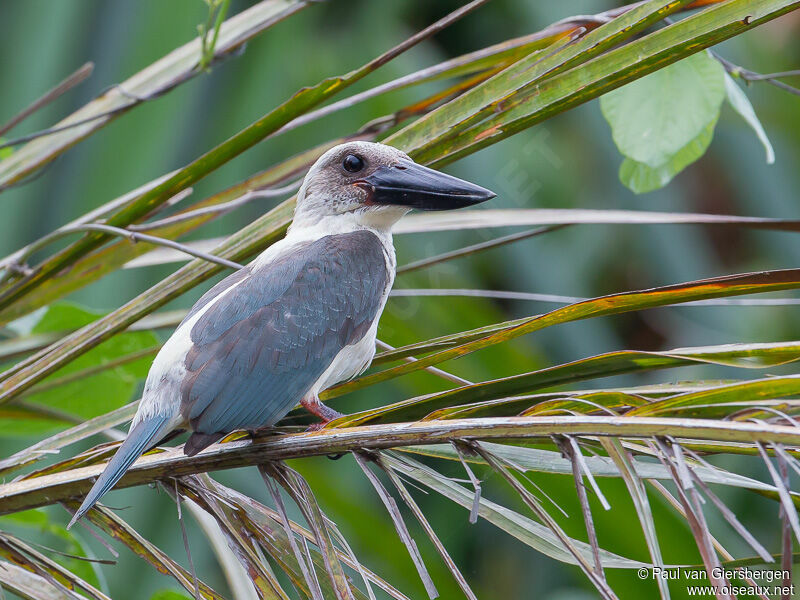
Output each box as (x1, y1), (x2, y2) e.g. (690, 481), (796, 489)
(0, 0), (800, 600)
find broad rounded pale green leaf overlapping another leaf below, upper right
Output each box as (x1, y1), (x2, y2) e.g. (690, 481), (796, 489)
(600, 52), (725, 168)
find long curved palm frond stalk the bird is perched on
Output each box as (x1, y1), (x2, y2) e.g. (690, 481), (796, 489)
(0, 416), (800, 514)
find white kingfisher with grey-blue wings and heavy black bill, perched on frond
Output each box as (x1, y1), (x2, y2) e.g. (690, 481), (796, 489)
(68, 141), (495, 527)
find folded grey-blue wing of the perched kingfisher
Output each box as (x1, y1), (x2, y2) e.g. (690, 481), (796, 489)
(181, 231), (389, 434)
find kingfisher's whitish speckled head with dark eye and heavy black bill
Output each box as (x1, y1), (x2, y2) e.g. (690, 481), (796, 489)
(295, 142), (495, 228)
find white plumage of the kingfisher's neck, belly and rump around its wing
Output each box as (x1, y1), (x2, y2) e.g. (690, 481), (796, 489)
(131, 209), (407, 434)
